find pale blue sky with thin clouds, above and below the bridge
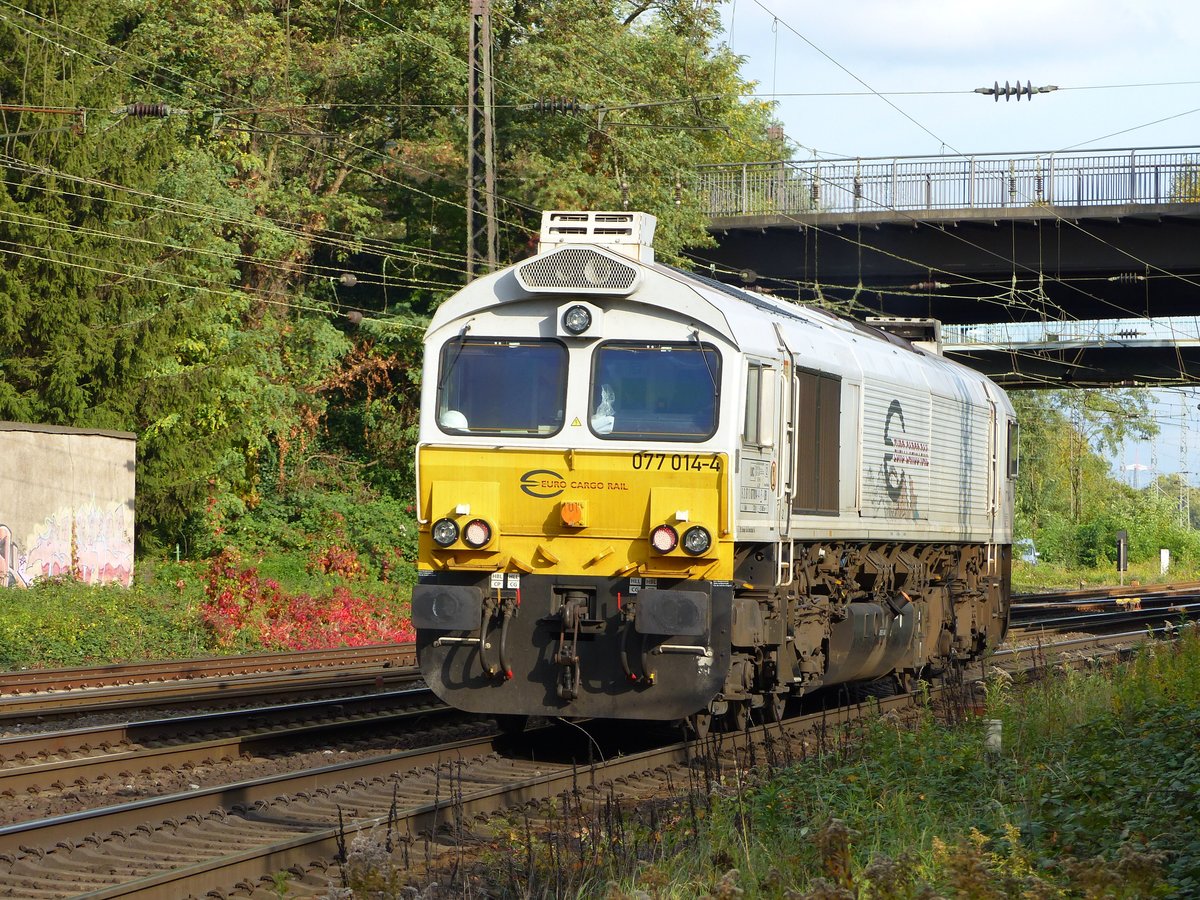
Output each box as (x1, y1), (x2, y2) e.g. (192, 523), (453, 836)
(719, 0), (1200, 486)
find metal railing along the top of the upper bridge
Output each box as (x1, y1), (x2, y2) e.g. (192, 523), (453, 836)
(697, 146), (1200, 217)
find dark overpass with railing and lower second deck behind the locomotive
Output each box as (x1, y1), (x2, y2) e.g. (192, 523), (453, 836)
(691, 148), (1200, 388)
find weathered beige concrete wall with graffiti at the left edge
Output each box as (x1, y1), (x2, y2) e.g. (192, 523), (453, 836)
(0, 421), (137, 588)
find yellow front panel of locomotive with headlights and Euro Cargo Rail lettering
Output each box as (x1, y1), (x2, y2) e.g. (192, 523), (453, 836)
(418, 446), (733, 581)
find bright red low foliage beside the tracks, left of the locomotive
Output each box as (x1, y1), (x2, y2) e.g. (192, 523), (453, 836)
(200, 551), (415, 650)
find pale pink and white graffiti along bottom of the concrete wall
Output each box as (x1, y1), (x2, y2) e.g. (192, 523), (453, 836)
(0, 503), (133, 587)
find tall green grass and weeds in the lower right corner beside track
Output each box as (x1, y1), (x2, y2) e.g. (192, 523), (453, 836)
(396, 628), (1200, 900)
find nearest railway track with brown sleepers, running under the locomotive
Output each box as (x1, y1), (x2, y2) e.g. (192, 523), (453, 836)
(0, 631), (1161, 900)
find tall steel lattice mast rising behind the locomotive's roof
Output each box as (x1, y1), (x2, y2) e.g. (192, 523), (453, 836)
(467, 0), (497, 281)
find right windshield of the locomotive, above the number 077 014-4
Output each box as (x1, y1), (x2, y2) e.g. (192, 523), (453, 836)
(588, 343), (721, 440)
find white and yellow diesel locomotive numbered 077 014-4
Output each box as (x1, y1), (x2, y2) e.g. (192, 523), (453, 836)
(413, 211), (1016, 733)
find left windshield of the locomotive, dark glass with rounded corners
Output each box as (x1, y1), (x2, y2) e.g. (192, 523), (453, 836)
(438, 338), (566, 436)
